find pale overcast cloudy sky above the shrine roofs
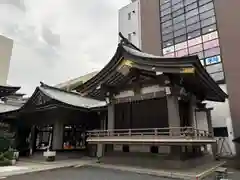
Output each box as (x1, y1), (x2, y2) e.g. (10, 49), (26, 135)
(0, 0), (130, 96)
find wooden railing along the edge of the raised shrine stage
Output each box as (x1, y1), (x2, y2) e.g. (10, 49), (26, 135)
(87, 127), (212, 138)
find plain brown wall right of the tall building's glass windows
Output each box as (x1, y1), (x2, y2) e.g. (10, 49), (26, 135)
(214, 0), (240, 155)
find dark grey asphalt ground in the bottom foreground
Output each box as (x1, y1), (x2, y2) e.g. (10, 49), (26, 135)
(4, 166), (178, 180)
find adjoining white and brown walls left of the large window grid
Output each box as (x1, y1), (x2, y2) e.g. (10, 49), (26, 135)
(119, 0), (162, 55)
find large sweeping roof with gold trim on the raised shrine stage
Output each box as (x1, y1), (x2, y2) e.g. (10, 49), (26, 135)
(76, 33), (227, 102)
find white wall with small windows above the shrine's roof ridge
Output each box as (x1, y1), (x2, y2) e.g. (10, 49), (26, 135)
(118, 0), (141, 48)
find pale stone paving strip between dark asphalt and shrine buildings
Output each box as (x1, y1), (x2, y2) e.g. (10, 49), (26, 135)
(0, 159), (225, 179)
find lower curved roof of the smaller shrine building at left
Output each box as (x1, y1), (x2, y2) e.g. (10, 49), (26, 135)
(20, 83), (106, 112)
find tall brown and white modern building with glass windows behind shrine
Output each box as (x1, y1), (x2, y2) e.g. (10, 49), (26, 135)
(119, 0), (240, 155)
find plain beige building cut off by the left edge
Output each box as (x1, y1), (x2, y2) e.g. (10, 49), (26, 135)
(0, 35), (13, 85)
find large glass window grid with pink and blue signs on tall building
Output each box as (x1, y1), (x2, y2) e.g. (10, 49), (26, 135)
(160, 0), (224, 79)
